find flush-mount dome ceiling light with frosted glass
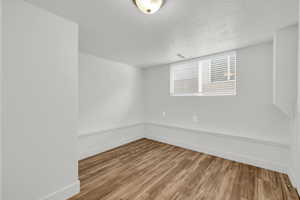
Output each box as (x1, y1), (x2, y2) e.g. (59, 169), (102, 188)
(133, 0), (164, 15)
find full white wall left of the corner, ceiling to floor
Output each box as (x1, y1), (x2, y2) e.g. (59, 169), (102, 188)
(79, 53), (144, 158)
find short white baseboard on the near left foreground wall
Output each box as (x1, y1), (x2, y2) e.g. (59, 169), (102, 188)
(41, 180), (80, 200)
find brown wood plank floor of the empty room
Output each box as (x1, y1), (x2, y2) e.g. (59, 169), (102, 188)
(71, 139), (299, 200)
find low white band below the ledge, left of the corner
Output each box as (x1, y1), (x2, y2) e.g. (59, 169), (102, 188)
(79, 124), (144, 160)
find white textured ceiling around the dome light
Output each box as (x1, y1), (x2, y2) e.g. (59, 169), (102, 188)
(26, 0), (298, 67)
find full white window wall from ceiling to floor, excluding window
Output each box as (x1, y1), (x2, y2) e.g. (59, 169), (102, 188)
(145, 42), (291, 172)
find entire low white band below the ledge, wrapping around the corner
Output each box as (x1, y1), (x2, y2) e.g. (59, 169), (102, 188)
(79, 123), (295, 184)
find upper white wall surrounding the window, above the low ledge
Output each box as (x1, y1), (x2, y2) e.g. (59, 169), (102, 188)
(144, 42), (290, 144)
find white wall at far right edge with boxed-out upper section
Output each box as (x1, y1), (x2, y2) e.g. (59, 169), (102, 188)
(273, 25), (300, 187)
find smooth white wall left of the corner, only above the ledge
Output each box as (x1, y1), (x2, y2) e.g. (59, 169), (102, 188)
(79, 53), (144, 135)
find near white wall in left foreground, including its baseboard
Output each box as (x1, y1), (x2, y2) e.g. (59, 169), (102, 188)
(3, 0), (79, 200)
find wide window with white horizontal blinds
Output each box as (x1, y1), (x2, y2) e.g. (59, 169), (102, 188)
(170, 52), (237, 96)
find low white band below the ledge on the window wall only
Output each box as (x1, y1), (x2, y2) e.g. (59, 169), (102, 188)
(145, 123), (289, 173)
